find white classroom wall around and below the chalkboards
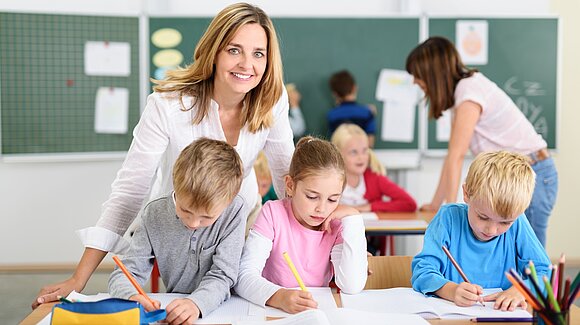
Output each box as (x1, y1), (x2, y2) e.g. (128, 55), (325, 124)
(0, 0), (580, 266)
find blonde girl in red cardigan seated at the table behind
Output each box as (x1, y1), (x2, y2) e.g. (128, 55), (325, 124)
(331, 123), (417, 212)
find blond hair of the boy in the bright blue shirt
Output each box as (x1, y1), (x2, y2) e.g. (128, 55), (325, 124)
(465, 151), (536, 218)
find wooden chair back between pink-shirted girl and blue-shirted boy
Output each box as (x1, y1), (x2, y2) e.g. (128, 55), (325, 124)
(365, 256), (413, 289)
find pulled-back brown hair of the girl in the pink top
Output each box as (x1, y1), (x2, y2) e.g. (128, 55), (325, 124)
(288, 136), (346, 189)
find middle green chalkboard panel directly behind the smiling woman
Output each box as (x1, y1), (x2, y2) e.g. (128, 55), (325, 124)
(149, 18), (419, 150)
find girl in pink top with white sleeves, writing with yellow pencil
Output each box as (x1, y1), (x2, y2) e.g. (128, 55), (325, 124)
(234, 136), (367, 313)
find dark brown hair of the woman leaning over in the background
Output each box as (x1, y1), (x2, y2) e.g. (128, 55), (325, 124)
(405, 36), (477, 119)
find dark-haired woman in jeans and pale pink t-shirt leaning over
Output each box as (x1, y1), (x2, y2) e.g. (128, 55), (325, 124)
(406, 37), (558, 246)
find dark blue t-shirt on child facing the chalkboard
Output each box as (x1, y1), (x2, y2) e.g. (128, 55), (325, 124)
(326, 102), (376, 134)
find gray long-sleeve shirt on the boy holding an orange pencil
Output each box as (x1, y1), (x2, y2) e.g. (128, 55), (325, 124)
(109, 195), (246, 316)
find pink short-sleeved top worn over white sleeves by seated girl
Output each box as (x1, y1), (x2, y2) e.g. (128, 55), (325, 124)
(252, 199), (342, 288)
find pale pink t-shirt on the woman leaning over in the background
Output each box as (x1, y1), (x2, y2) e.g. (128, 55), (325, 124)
(452, 72), (547, 155)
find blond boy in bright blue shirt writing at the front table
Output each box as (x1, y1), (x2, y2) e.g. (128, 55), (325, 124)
(411, 151), (550, 311)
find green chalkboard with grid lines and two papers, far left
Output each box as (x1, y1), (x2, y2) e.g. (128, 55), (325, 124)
(0, 13), (139, 156)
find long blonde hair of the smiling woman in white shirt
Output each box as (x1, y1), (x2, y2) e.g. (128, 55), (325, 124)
(151, 3), (283, 133)
